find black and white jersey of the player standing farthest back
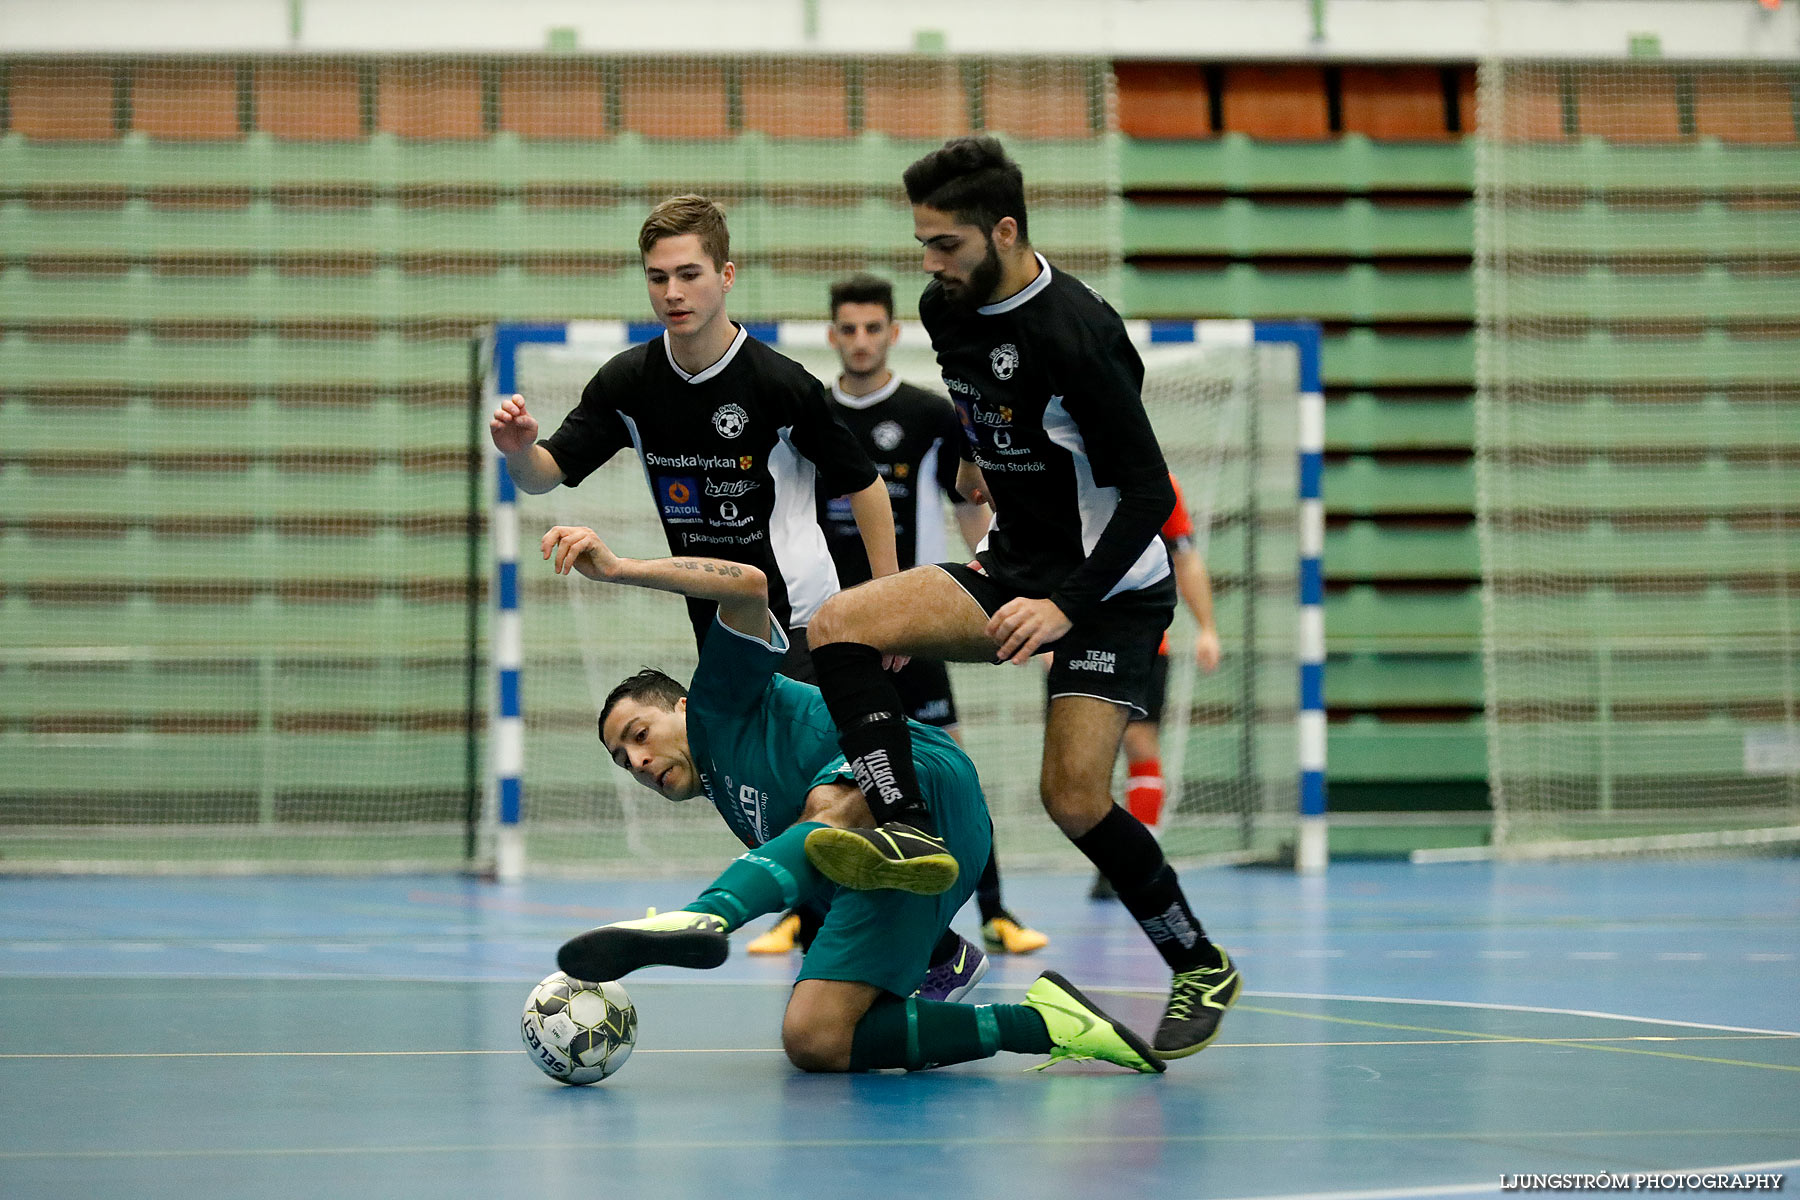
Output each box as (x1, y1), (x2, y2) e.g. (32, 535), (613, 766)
(819, 376), (963, 588)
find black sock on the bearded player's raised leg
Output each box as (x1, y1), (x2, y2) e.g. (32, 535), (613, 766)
(812, 642), (936, 833)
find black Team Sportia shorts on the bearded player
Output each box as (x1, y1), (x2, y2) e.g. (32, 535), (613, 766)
(938, 563), (1175, 716)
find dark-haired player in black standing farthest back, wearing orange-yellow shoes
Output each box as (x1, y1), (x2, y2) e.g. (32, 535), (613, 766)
(749, 275), (1049, 957)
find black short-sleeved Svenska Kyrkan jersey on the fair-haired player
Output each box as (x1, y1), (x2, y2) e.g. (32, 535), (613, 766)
(540, 326), (875, 639)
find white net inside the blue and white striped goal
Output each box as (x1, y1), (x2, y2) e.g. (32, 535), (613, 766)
(502, 324), (1298, 873)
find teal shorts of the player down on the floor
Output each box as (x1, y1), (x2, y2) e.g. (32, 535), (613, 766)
(799, 725), (994, 997)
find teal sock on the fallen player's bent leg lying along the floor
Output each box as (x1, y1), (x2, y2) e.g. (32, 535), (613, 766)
(850, 995), (1049, 1070)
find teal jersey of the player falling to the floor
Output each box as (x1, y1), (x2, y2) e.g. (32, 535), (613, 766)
(688, 615), (855, 846)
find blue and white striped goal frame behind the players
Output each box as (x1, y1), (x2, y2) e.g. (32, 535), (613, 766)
(486, 320), (1330, 880)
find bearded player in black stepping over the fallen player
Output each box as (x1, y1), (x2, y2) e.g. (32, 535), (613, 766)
(806, 139), (1242, 1058)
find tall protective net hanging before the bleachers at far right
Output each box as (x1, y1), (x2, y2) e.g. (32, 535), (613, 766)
(1476, 59), (1800, 855)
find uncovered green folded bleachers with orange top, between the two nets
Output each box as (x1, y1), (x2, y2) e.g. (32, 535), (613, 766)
(1118, 63), (1487, 855)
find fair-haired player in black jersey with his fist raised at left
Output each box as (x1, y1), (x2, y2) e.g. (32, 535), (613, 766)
(490, 196), (896, 678)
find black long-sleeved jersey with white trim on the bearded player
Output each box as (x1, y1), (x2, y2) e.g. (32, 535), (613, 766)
(918, 255), (1175, 621)
